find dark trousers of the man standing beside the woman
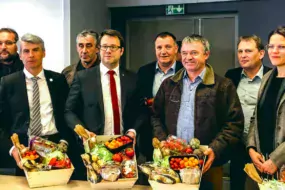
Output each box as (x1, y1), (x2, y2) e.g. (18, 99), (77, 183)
(230, 142), (251, 190)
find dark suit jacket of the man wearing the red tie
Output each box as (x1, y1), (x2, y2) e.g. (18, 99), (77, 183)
(65, 66), (139, 135)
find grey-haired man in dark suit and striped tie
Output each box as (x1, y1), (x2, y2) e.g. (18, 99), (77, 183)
(0, 34), (68, 174)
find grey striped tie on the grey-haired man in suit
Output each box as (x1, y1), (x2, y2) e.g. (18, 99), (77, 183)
(31, 77), (42, 136)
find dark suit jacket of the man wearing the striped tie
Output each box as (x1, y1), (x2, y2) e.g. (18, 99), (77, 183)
(0, 70), (69, 155)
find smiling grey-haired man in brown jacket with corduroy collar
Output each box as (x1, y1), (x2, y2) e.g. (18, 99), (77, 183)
(152, 35), (244, 190)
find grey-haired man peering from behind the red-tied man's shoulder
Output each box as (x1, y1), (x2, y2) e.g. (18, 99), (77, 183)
(62, 30), (100, 86)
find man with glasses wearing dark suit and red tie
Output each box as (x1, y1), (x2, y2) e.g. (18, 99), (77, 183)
(65, 29), (139, 141)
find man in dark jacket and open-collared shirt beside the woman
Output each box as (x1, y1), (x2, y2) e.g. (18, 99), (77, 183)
(225, 35), (270, 190)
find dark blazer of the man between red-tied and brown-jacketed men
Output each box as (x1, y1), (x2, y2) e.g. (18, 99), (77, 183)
(137, 61), (183, 160)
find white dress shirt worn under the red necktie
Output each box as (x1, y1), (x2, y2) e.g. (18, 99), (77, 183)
(100, 62), (123, 135)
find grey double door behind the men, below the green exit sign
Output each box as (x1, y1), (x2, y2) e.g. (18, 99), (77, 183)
(126, 14), (238, 76)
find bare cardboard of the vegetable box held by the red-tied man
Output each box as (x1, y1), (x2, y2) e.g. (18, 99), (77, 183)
(90, 135), (138, 190)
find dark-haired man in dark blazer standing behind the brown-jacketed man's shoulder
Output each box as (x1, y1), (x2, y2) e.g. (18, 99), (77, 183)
(137, 32), (183, 161)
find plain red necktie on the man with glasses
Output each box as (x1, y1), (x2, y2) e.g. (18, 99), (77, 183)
(108, 70), (120, 135)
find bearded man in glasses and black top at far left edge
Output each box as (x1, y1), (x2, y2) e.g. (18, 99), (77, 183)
(0, 28), (24, 78)
